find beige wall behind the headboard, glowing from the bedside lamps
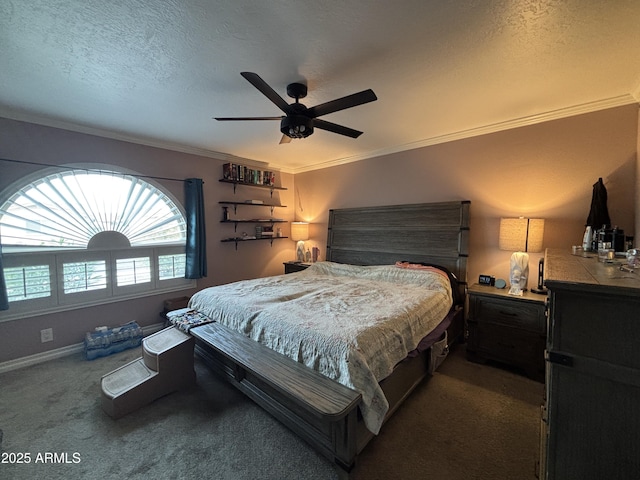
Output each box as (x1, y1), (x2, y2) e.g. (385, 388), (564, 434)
(295, 105), (638, 286)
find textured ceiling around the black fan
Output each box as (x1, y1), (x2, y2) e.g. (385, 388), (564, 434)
(0, 0), (640, 172)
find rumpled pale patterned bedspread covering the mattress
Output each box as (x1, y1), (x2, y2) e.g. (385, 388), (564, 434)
(189, 262), (452, 434)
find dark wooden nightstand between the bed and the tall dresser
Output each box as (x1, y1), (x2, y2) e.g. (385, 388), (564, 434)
(467, 284), (547, 382)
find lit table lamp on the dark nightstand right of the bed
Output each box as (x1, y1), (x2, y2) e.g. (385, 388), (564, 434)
(499, 217), (544, 295)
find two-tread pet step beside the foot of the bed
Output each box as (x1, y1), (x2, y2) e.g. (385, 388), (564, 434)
(101, 327), (195, 418)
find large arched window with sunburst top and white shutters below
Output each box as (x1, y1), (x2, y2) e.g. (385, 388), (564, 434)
(0, 169), (194, 319)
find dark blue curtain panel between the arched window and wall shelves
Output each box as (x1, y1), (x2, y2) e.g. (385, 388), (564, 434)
(184, 178), (207, 278)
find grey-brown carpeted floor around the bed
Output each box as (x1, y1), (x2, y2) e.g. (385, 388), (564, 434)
(0, 347), (543, 480)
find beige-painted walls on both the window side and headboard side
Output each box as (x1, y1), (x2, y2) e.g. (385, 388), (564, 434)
(0, 105), (640, 363)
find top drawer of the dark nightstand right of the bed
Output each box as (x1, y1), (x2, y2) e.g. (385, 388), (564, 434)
(469, 295), (546, 334)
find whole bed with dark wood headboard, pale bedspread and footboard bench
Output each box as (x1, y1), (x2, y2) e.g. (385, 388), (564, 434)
(189, 201), (470, 478)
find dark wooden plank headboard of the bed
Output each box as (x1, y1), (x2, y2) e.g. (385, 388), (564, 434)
(326, 201), (471, 288)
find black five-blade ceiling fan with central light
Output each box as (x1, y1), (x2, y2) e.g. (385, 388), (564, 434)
(215, 72), (378, 143)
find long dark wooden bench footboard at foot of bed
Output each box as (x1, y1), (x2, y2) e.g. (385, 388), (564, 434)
(189, 323), (361, 476)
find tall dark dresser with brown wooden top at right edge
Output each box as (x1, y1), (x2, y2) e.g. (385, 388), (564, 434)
(540, 250), (640, 480)
